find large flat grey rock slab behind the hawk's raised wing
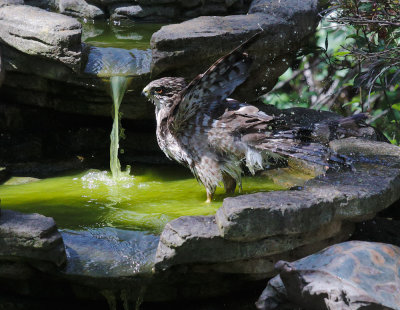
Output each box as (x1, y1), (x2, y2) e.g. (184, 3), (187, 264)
(151, 0), (318, 101)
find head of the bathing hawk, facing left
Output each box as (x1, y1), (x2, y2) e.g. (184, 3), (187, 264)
(142, 77), (186, 109)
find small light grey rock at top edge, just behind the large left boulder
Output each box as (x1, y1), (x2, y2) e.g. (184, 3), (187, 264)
(59, 0), (105, 19)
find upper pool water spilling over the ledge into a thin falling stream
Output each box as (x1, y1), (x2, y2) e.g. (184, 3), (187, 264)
(83, 23), (156, 179)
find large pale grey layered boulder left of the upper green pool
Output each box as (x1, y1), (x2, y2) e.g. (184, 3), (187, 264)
(0, 5), (82, 70)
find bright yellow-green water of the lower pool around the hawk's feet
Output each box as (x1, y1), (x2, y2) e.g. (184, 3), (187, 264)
(0, 165), (282, 233)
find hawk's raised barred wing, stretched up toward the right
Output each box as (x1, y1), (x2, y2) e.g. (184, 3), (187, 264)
(168, 32), (262, 132)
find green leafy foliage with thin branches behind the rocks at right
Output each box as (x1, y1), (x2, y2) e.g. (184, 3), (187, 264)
(264, 0), (400, 144)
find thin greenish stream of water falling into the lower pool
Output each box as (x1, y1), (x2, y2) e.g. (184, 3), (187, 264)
(110, 76), (130, 179)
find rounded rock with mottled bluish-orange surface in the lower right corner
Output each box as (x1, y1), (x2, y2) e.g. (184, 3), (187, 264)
(257, 241), (400, 310)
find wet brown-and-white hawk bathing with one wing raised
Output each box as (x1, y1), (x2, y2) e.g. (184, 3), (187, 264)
(143, 33), (365, 202)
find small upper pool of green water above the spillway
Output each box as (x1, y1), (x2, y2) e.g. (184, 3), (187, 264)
(82, 21), (163, 50)
